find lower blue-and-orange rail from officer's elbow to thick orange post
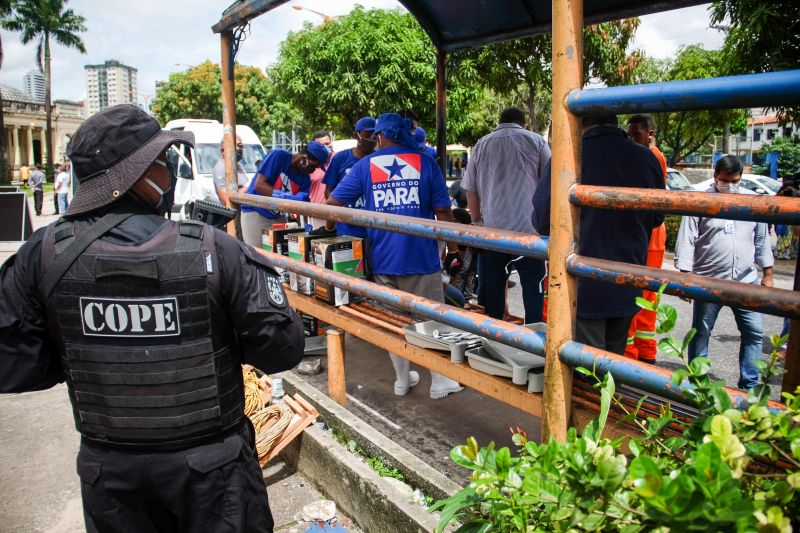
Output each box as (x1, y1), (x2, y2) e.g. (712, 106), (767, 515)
(258, 250), (545, 355)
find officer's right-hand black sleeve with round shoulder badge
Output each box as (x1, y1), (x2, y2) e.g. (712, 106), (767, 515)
(215, 231), (305, 373)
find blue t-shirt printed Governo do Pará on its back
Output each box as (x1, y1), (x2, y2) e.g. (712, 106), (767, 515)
(332, 146), (450, 276)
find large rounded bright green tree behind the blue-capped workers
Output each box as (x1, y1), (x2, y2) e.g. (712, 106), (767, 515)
(268, 6), (483, 141)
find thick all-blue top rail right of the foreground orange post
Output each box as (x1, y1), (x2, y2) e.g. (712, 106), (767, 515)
(567, 70), (800, 116)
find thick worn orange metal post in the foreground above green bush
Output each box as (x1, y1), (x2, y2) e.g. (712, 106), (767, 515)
(542, 0), (583, 441)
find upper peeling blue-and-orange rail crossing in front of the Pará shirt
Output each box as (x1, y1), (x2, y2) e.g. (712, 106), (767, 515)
(231, 193), (548, 259)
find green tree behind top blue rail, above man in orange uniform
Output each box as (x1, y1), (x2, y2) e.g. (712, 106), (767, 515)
(635, 45), (748, 166)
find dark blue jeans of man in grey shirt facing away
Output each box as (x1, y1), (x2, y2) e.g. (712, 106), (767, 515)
(478, 250), (546, 324)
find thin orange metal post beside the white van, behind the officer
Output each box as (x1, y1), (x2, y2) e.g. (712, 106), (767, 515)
(220, 30), (239, 237)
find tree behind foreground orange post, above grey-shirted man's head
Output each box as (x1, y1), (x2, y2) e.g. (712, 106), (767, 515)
(458, 18), (642, 131)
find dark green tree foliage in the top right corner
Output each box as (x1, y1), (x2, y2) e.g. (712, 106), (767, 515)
(710, 0), (800, 120)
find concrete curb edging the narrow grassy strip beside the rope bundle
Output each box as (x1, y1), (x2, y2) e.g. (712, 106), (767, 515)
(280, 372), (461, 533)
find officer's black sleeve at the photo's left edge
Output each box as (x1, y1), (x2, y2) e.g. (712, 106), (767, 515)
(0, 229), (64, 392)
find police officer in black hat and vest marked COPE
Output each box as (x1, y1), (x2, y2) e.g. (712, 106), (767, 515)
(0, 105), (303, 532)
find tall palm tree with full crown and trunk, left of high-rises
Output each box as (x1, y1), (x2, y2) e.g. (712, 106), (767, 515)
(2, 0), (86, 181)
